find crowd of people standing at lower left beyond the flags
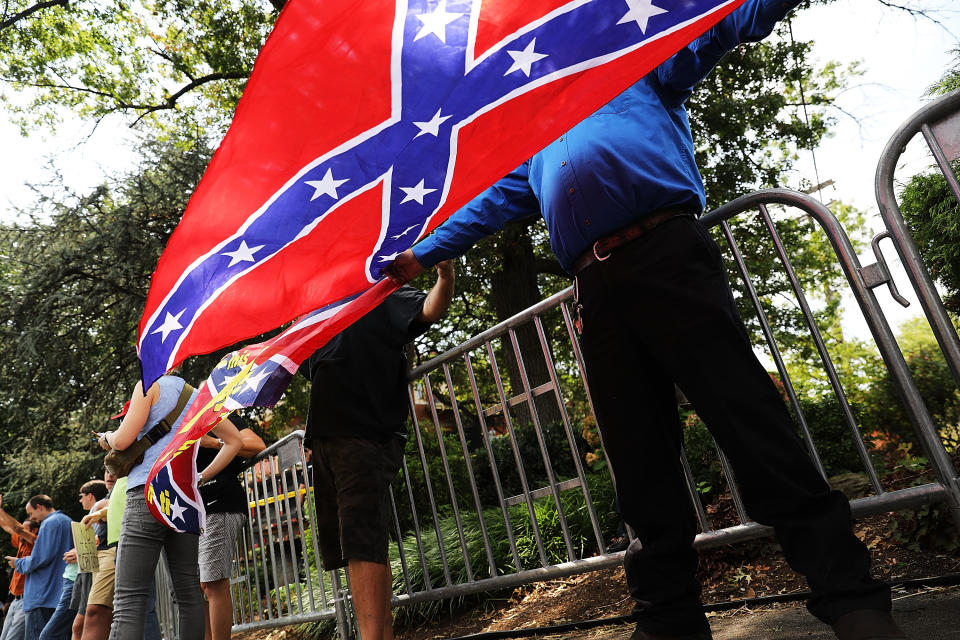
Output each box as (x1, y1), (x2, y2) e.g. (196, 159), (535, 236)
(0, 390), (266, 640)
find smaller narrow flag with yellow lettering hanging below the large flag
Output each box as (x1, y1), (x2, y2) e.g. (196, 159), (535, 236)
(145, 280), (394, 533)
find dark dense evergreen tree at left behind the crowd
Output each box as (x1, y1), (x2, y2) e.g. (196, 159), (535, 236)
(0, 138), (228, 505)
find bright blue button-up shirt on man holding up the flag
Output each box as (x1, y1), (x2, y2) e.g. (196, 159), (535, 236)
(413, 0), (799, 272)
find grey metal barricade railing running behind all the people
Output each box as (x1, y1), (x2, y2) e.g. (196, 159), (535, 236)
(208, 93), (960, 637)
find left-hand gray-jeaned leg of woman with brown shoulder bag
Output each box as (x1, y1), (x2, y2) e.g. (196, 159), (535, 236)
(110, 488), (169, 640)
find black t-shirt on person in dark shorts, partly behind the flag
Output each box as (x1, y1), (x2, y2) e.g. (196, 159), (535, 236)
(300, 287), (430, 442)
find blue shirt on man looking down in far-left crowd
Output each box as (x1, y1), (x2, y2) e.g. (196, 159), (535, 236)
(17, 511), (73, 611)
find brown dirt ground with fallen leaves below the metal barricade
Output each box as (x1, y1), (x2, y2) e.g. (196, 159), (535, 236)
(234, 514), (960, 640)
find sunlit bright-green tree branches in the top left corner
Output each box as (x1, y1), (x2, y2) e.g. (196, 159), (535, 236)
(0, 0), (276, 135)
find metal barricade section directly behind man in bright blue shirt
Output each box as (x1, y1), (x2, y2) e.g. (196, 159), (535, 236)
(397, 189), (957, 603)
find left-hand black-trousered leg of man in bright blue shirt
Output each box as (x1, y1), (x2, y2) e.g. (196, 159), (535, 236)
(577, 266), (709, 635)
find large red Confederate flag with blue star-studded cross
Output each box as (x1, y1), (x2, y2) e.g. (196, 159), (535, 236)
(137, 0), (742, 388)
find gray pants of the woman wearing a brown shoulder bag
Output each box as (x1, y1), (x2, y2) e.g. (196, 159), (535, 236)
(110, 486), (204, 640)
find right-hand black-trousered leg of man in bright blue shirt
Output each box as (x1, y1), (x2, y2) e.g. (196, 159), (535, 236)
(614, 221), (890, 623)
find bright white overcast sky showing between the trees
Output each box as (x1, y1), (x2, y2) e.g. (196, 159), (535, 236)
(0, 0), (960, 338)
